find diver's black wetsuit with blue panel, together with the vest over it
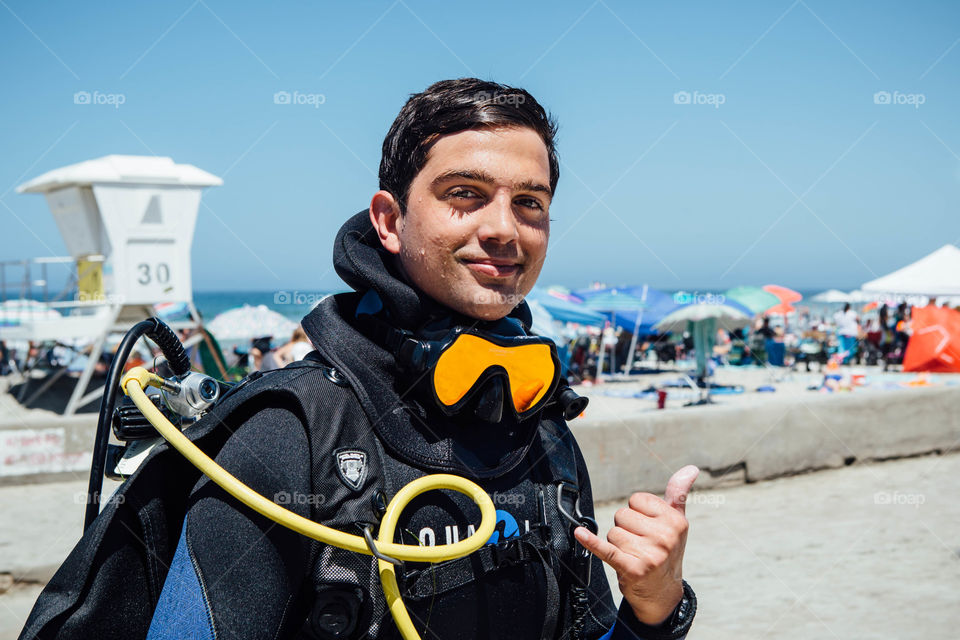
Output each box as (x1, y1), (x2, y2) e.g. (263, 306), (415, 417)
(22, 212), (695, 640)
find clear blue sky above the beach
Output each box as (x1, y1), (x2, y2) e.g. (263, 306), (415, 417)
(0, 0), (960, 290)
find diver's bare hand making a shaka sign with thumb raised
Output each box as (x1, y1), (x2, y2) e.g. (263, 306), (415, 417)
(574, 465), (700, 625)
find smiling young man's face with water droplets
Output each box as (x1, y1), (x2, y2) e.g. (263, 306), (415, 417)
(371, 127), (552, 320)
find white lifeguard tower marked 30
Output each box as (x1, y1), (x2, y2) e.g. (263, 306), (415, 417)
(0, 155), (223, 415)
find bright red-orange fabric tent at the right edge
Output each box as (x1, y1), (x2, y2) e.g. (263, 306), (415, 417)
(903, 307), (960, 373)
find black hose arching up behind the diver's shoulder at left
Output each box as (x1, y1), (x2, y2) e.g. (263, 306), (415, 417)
(83, 318), (190, 531)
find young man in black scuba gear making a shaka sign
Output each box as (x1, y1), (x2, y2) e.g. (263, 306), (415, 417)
(21, 78), (697, 640)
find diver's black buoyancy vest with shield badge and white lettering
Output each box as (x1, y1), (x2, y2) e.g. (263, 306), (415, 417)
(23, 352), (589, 640)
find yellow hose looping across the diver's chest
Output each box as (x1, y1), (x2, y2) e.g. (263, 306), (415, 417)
(120, 367), (497, 640)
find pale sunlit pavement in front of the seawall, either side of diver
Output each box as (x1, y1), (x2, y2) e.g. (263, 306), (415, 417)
(0, 454), (960, 640)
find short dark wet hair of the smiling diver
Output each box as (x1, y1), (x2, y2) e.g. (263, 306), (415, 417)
(380, 78), (560, 213)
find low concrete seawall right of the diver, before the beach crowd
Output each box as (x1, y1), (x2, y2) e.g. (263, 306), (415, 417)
(571, 387), (960, 502)
